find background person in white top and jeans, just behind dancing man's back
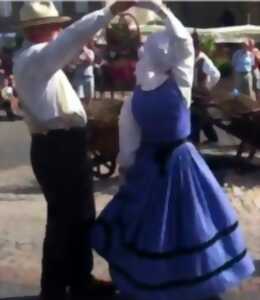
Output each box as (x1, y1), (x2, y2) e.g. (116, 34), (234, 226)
(72, 46), (95, 107)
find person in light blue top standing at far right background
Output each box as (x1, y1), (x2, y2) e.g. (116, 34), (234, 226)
(232, 41), (255, 100)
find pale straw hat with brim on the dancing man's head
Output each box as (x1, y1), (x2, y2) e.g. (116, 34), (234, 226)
(19, 1), (71, 28)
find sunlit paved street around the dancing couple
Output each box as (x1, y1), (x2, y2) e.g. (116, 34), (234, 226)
(0, 122), (260, 300)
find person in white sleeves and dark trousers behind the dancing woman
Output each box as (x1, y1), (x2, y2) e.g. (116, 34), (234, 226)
(191, 31), (220, 144)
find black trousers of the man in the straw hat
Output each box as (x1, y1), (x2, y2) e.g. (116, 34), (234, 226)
(31, 128), (95, 300)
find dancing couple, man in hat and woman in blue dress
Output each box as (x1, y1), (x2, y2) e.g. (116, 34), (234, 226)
(14, 0), (254, 300)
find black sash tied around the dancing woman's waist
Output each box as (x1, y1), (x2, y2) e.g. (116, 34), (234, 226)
(154, 138), (188, 175)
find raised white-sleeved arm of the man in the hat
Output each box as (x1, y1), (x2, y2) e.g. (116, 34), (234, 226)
(33, 1), (134, 77)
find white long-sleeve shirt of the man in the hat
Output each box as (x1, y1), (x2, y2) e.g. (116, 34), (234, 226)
(14, 8), (113, 133)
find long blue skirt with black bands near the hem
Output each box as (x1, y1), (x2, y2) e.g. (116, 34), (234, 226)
(93, 143), (254, 300)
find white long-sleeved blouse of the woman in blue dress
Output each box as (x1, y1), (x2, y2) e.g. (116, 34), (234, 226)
(118, 4), (194, 169)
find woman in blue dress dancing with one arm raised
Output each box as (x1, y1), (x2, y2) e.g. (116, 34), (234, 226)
(93, 1), (254, 300)
